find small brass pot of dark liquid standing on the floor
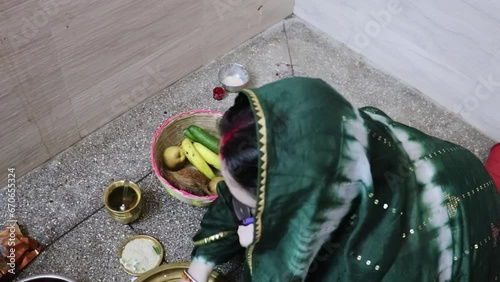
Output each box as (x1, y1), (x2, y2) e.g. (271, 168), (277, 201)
(104, 180), (142, 224)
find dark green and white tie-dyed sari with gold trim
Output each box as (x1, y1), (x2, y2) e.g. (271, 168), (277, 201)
(192, 78), (500, 282)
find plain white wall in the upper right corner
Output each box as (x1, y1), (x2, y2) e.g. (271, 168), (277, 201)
(295, 0), (500, 141)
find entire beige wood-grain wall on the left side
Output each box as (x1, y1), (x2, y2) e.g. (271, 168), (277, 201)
(0, 0), (293, 184)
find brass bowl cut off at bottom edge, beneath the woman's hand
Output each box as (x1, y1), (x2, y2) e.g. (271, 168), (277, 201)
(134, 262), (223, 282)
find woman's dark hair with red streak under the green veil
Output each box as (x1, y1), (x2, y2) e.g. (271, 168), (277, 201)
(219, 93), (259, 196)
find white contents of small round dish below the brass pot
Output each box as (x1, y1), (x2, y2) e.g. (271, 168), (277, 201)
(120, 238), (161, 273)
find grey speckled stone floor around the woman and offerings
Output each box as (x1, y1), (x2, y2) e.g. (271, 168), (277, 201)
(0, 18), (494, 282)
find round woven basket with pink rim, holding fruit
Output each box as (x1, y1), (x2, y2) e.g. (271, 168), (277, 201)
(151, 110), (222, 207)
